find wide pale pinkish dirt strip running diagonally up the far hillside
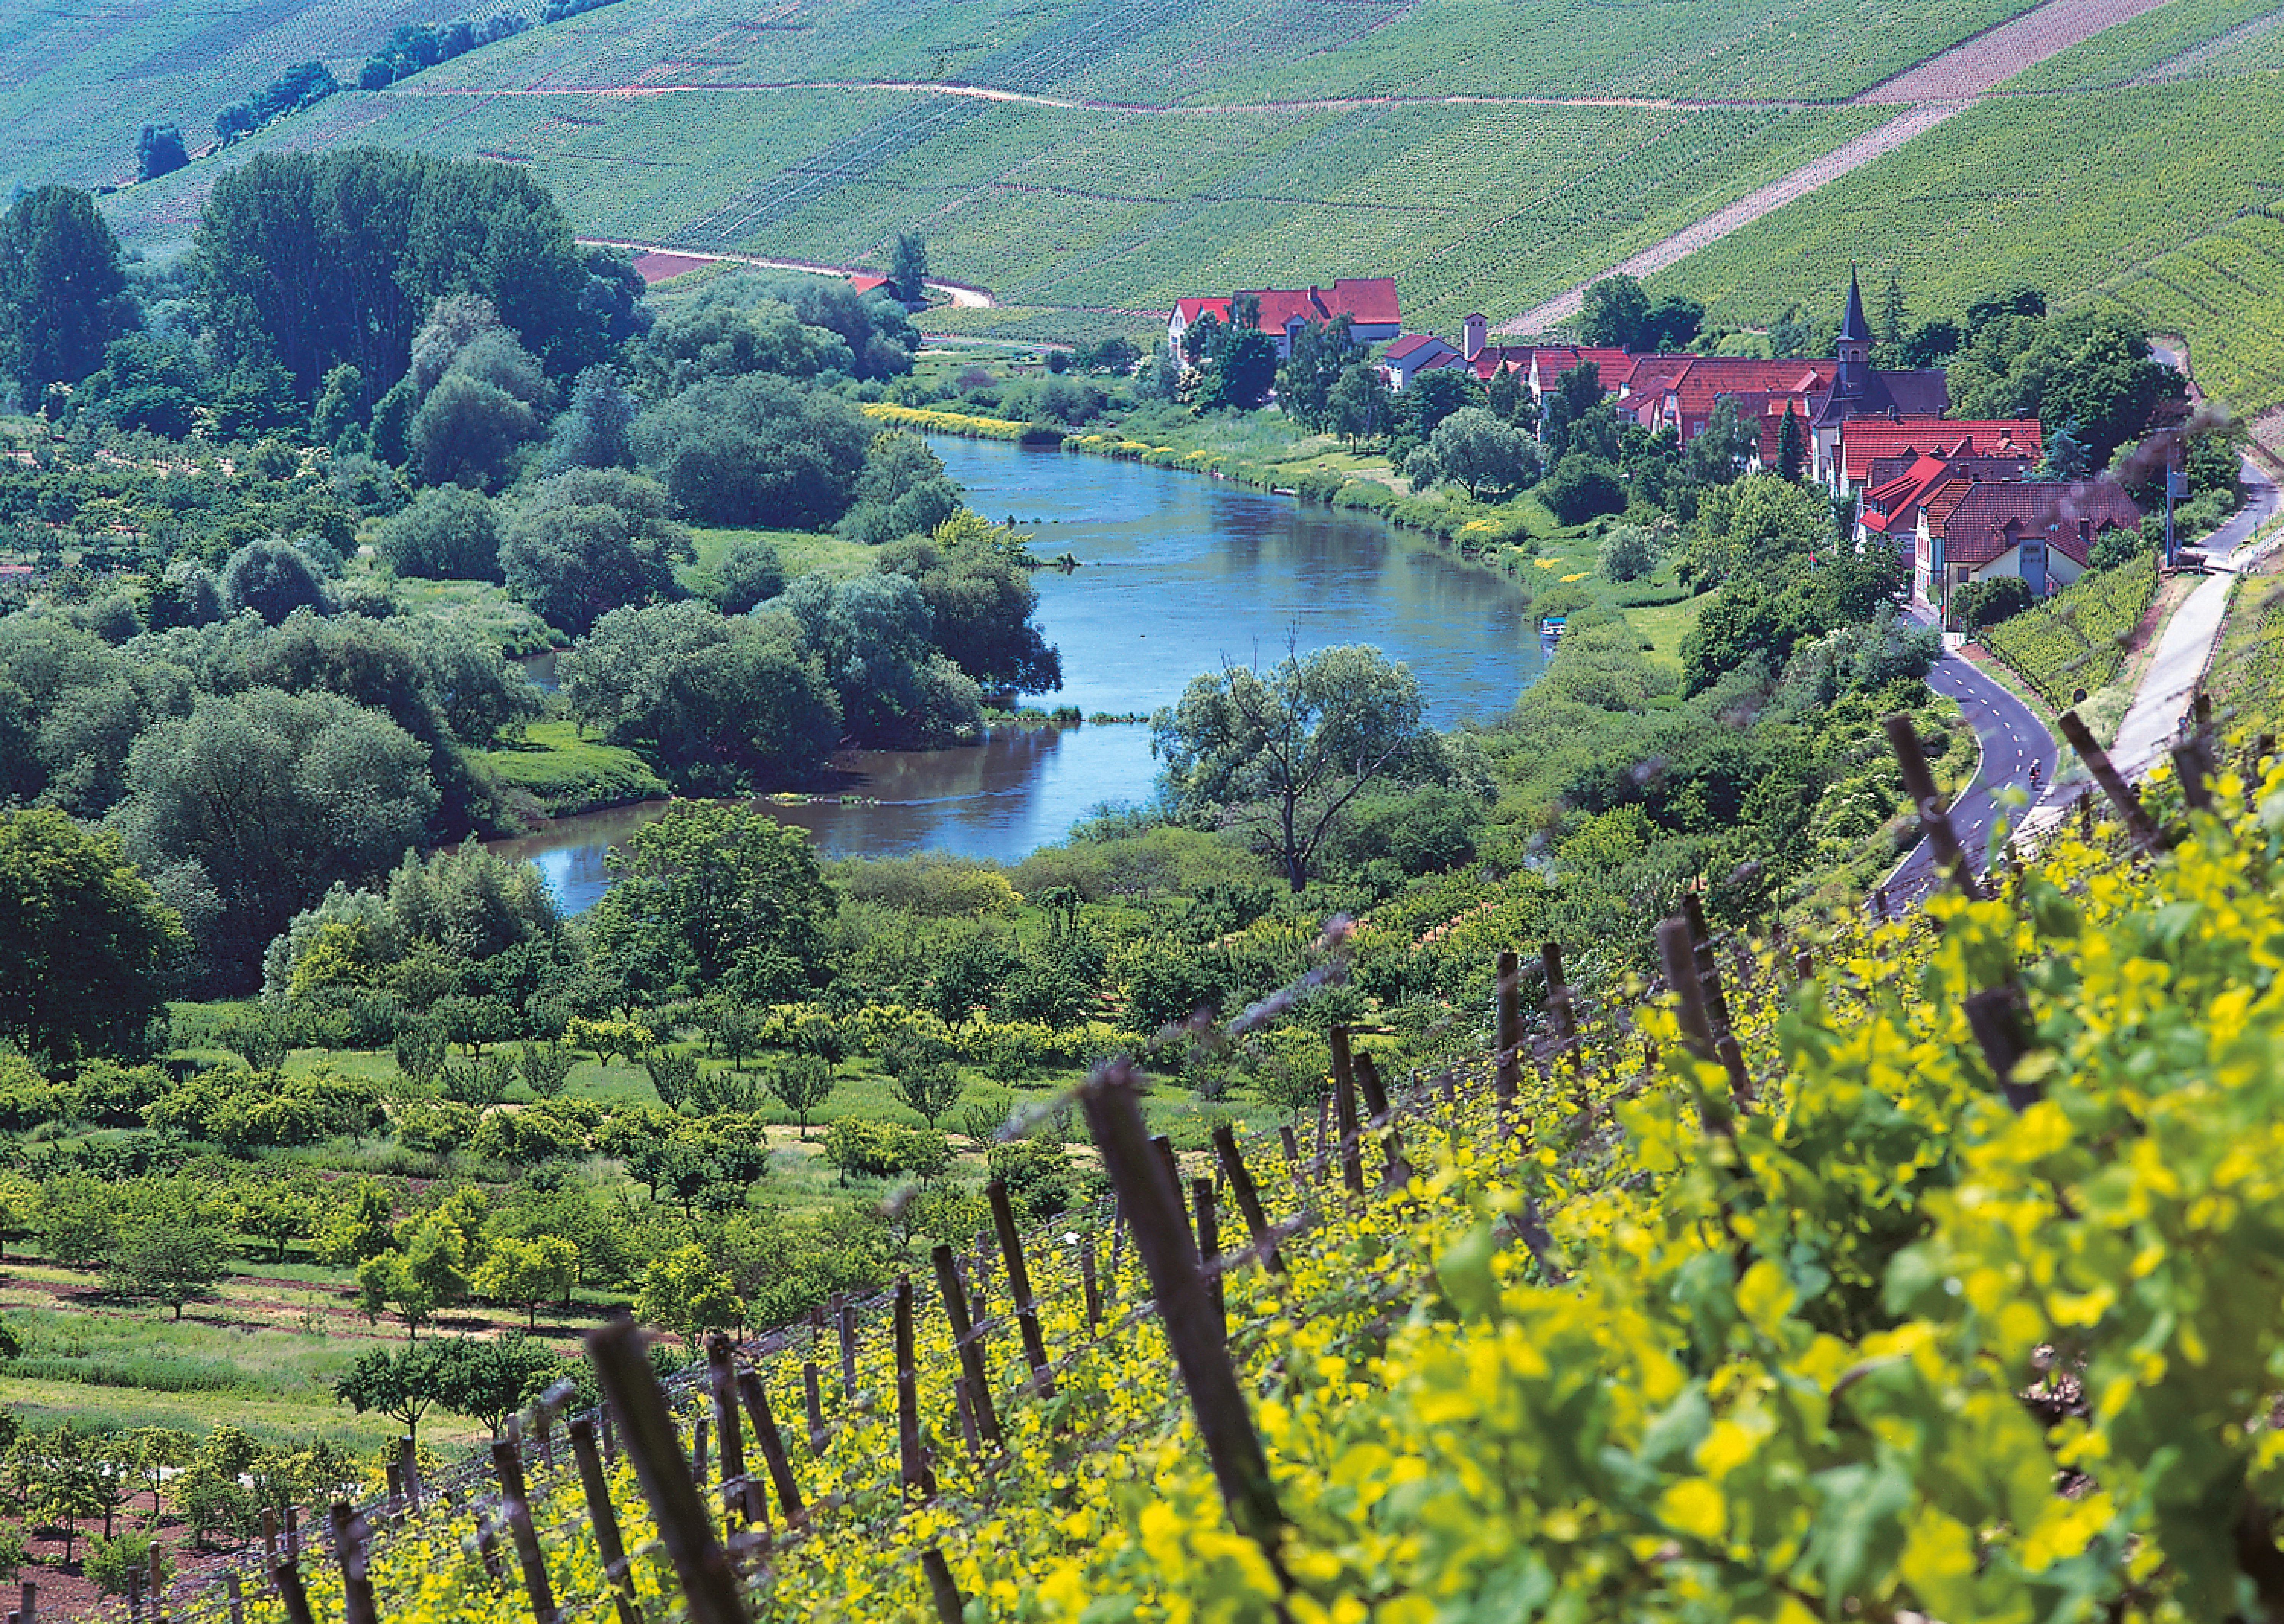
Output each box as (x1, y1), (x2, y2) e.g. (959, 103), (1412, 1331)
(1498, 0), (2165, 333)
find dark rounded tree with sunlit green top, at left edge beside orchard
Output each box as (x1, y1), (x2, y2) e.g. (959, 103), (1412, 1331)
(0, 808), (187, 1067)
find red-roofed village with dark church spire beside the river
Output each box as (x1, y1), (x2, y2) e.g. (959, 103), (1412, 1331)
(1167, 276), (2170, 630)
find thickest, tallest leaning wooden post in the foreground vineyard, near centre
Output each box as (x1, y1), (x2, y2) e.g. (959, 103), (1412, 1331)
(1078, 1062), (1284, 1574)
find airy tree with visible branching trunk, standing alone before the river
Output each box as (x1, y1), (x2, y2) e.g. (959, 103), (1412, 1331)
(1151, 644), (1446, 891)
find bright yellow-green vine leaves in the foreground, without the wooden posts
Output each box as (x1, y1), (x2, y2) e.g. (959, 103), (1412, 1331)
(201, 767), (2284, 1624)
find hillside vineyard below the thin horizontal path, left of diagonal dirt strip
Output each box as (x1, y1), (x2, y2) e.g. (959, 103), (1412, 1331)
(112, 91), (1887, 340)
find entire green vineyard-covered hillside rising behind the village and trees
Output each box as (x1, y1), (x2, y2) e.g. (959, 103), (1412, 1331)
(45, 0), (2284, 425)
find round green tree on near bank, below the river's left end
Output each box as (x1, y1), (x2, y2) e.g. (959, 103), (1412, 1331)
(589, 802), (836, 996)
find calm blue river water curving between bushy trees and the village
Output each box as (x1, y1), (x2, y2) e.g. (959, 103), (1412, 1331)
(491, 438), (1544, 912)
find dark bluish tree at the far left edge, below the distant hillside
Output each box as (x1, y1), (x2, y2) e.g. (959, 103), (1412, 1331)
(0, 185), (135, 409)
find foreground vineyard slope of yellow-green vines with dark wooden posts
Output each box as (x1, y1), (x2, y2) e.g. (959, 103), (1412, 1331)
(103, 728), (2284, 1624)
